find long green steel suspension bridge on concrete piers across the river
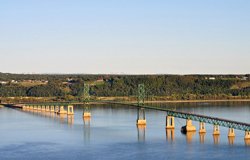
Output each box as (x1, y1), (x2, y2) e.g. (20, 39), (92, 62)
(5, 84), (250, 141)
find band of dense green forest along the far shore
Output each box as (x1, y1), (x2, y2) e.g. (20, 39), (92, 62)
(0, 73), (250, 100)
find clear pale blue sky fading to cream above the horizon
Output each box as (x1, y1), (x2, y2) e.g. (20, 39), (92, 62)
(0, 0), (250, 74)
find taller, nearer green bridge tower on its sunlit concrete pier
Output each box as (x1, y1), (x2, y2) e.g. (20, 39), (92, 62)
(137, 84), (146, 125)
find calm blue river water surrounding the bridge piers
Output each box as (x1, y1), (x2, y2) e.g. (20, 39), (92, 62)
(0, 102), (250, 160)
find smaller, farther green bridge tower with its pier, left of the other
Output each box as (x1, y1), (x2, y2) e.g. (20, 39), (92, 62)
(83, 84), (91, 117)
